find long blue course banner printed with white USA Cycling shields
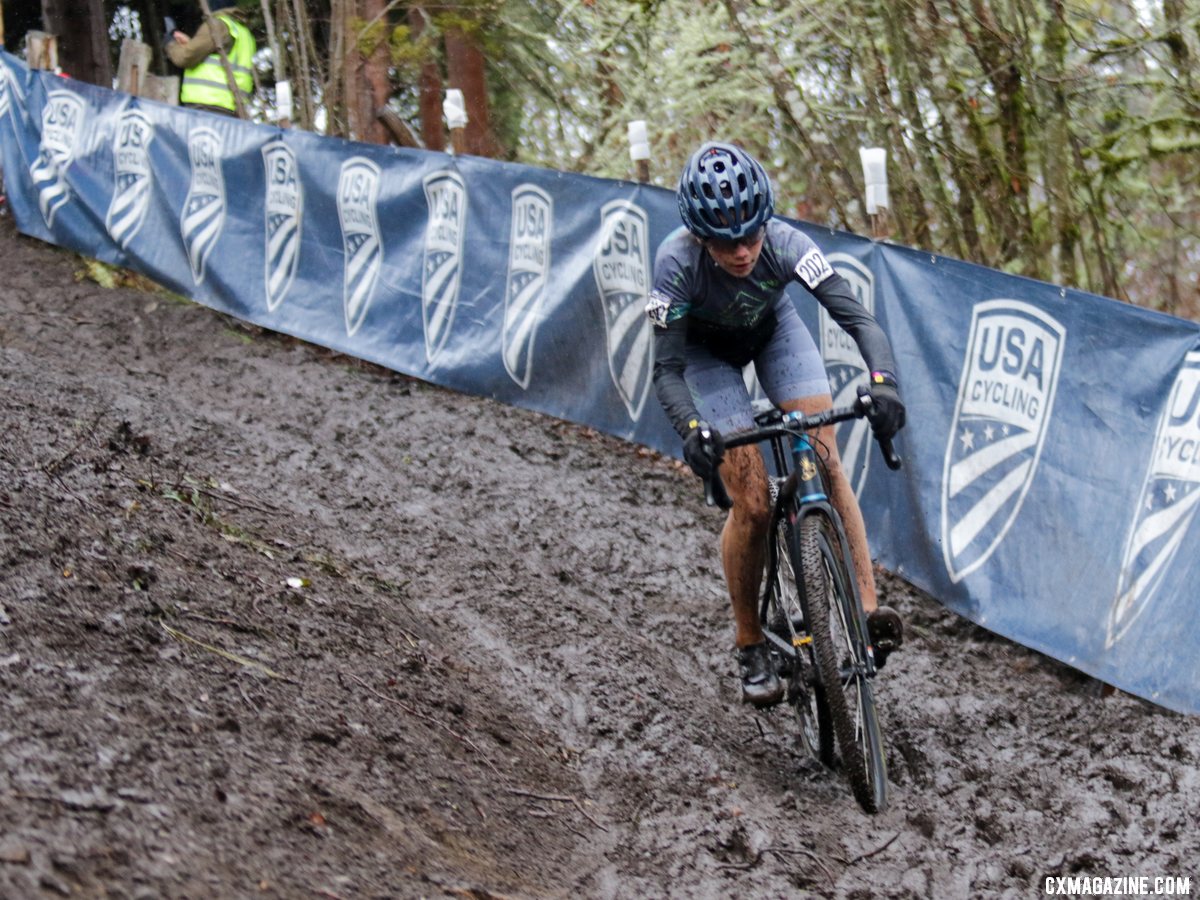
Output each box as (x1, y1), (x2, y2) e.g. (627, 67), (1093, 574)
(0, 54), (1200, 713)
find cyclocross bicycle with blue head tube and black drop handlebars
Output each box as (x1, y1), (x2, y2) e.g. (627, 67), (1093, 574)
(706, 388), (901, 812)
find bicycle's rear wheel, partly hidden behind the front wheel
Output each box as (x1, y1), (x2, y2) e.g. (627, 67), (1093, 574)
(763, 518), (835, 766)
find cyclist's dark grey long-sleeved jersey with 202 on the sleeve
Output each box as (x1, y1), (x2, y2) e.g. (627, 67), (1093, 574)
(646, 218), (896, 437)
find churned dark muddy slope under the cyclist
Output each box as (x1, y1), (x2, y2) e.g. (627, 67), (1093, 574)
(0, 218), (1200, 900)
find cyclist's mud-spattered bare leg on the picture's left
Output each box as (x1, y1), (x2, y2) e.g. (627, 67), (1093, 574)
(721, 446), (772, 647)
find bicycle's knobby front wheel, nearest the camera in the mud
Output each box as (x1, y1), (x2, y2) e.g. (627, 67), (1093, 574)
(798, 512), (888, 812)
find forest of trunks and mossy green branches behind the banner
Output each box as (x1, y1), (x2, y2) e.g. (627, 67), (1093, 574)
(0, 0), (1200, 319)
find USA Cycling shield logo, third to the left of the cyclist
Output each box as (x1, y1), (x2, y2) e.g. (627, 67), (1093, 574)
(421, 172), (467, 362)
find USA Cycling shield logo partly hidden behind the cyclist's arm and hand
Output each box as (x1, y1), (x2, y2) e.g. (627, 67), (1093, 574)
(817, 253), (875, 497)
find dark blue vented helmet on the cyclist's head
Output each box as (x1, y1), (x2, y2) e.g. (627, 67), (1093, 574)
(678, 142), (774, 240)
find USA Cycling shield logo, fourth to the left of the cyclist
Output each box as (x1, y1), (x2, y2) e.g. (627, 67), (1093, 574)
(337, 156), (383, 335)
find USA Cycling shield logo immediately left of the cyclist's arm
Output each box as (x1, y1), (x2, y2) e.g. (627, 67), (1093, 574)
(592, 200), (653, 421)
